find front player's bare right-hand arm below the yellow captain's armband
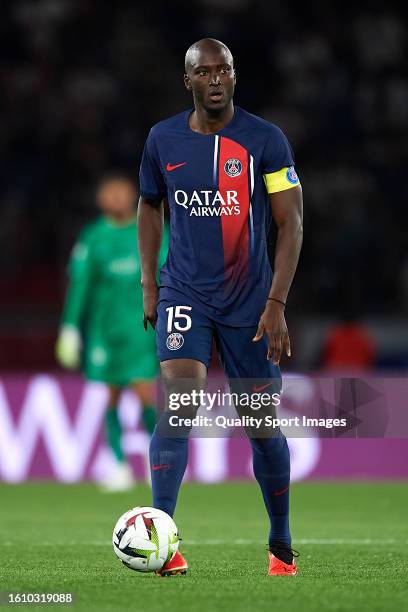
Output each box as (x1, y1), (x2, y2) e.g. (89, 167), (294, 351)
(254, 185), (303, 364)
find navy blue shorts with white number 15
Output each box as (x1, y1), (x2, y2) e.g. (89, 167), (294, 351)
(156, 294), (281, 380)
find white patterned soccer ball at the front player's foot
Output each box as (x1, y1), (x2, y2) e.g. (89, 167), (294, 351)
(112, 506), (179, 572)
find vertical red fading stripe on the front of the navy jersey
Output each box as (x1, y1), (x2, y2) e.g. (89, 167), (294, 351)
(218, 136), (250, 283)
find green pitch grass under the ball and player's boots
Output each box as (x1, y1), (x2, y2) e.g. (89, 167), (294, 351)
(0, 483), (408, 612)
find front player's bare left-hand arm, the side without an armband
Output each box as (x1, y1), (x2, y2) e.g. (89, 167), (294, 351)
(137, 197), (164, 329)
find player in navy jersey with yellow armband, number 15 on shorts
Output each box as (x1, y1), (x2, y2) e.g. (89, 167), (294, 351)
(138, 39), (302, 575)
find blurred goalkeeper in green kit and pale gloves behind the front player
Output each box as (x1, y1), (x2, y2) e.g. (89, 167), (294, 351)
(56, 172), (167, 491)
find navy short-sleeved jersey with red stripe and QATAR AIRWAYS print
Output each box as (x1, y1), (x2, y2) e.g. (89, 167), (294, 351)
(140, 106), (299, 326)
